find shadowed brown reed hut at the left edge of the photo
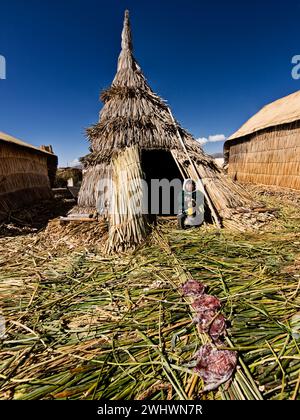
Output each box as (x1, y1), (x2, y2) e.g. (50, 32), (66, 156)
(0, 132), (57, 219)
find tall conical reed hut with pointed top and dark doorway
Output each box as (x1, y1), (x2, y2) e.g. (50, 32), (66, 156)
(76, 11), (262, 251)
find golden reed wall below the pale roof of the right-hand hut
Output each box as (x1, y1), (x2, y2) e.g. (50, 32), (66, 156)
(225, 121), (300, 190)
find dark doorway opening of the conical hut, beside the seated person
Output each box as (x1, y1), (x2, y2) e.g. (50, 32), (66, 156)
(141, 150), (184, 217)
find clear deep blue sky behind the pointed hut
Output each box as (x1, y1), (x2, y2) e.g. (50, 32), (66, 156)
(0, 0), (300, 165)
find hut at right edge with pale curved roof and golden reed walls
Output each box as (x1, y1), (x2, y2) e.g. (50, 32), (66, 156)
(224, 91), (300, 190)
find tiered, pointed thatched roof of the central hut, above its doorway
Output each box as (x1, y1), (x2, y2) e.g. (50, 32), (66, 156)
(84, 11), (211, 164)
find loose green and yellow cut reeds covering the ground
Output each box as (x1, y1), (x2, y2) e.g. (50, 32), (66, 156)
(0, 187), (300, 400)
